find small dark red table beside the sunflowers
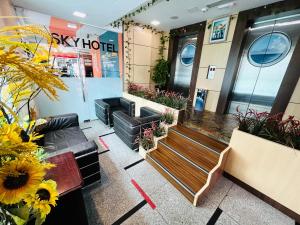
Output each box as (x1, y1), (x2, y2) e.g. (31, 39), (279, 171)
(44, 152), (88, 225)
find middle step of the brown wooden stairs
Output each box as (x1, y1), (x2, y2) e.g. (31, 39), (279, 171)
(162, 130), (219, 173)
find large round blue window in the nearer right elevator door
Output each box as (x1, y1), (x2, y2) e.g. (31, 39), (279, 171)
(248, 32), (291, 67)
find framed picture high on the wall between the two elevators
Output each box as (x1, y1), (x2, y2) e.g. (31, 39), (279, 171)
(210, 17), (230, 43)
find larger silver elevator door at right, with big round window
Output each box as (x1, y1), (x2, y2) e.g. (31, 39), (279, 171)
(228, 14), (300, 113)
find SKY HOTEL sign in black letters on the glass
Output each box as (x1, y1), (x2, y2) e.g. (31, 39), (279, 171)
(52, 33), (118, 52)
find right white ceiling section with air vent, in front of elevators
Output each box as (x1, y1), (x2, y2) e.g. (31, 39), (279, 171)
(134, 0), (282, 30)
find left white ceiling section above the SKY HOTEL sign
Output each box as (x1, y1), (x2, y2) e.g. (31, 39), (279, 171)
(12, 0), (147, 27)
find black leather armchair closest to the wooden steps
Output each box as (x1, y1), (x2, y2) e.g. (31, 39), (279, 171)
(113, 107), (161, 149)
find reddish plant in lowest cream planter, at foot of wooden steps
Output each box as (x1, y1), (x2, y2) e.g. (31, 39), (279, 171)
(138, 128), (155, 158)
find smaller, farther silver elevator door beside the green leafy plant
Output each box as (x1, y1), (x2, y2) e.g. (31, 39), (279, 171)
(173, 35), (197, 96)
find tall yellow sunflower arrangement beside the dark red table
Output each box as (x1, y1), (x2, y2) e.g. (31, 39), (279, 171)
(0, 25), (67, 225)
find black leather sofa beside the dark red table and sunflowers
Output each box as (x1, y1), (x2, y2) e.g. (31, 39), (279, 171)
(36, 113), (101, 186)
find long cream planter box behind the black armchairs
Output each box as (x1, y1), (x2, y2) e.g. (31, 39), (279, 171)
(123, 92), (185, 125)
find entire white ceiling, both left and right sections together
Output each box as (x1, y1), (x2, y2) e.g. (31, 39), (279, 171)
(12, 0), (281, 31)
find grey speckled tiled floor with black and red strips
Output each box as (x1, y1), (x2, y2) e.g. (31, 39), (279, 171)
(82, 120), (295, 225)
